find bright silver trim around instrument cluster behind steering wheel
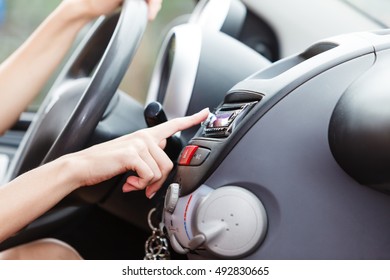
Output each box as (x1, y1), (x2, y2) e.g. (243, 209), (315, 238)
(146, 0), (232, 119)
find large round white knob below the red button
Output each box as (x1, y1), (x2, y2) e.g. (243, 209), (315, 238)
(194, 186), (268, 258)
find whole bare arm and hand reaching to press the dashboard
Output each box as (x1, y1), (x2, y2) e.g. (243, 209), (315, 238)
(0, 109), (208, 242)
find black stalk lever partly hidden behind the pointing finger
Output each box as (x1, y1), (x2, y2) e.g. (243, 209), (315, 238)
(144, 101), (183, 162)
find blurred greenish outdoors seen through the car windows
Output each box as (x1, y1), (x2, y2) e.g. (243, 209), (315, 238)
(0, 0), (195, 110)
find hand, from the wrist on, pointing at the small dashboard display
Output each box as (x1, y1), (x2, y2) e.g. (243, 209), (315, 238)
(68, 109), (209, 198)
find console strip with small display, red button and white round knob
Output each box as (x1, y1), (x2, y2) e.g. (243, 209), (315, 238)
(160, 92), (267, 258)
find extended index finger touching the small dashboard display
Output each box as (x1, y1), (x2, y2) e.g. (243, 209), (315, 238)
(150, 108), (210, 143)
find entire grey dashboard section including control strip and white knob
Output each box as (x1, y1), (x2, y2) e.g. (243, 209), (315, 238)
(162, 31), (390, 259)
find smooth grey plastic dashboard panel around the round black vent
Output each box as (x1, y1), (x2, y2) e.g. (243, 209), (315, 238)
(168, 30), (390, 259)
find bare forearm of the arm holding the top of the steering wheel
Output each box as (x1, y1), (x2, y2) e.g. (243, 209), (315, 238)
(0, 1), (92, 133)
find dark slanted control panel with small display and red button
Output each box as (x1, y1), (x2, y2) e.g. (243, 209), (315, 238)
(173, 92), (264, 195)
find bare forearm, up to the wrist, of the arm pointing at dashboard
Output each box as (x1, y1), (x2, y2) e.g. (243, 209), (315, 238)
(0, 156), (79, 243)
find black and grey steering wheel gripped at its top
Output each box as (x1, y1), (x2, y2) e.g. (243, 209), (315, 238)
(5, 0), (147, 181)
